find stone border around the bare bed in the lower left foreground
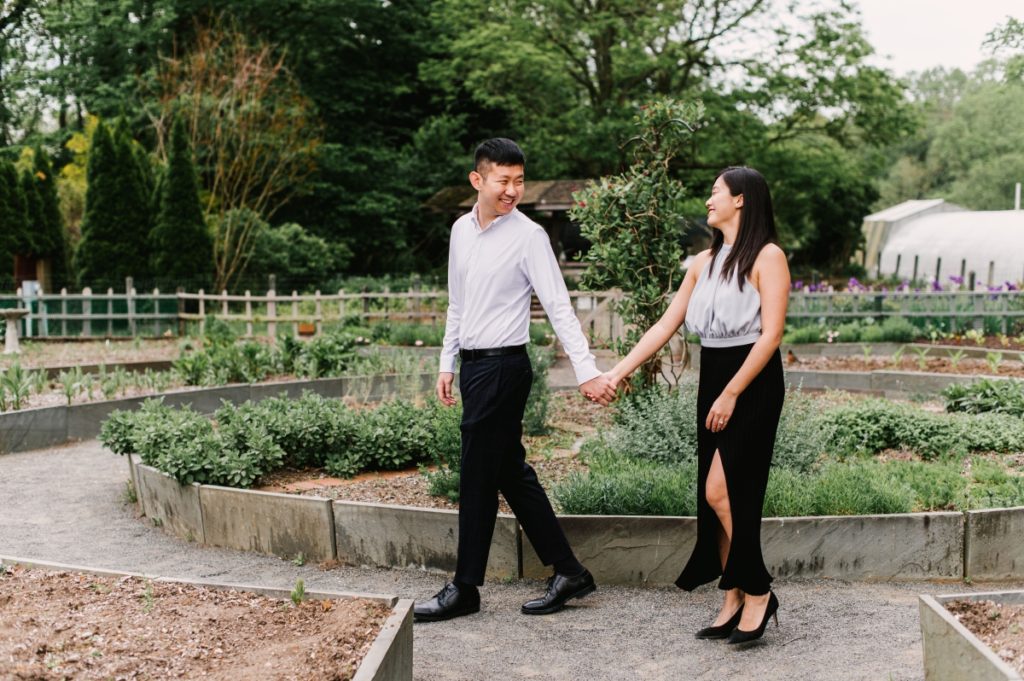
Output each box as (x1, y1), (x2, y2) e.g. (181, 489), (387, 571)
(0, 555), (413, 681)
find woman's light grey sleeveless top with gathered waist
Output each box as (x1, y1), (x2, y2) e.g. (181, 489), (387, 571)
(686, 244), (761, 347)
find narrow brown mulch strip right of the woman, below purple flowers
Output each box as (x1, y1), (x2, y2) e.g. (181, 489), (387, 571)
(785, 348), (1024, 378)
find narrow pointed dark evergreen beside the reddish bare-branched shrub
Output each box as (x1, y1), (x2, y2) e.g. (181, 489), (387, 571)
(150, 119), (213, 287)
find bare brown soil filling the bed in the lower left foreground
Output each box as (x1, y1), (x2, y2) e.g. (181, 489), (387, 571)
(0, 567), (389, 681)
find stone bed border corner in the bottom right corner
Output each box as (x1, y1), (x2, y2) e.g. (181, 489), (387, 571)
(918, 591), (1024, 681)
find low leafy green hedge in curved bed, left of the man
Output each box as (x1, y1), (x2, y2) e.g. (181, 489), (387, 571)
(99, 392), (461, 487)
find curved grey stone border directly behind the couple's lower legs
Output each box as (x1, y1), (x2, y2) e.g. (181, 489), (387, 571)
(131, 450), (1024, 586)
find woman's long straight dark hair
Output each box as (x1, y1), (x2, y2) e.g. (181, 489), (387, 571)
(709, 166), (778, 291)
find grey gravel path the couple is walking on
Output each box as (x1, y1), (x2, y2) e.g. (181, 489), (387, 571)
(0, 441), (1020, 681)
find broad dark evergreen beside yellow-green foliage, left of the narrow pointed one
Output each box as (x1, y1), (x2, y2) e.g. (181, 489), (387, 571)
(75, 122), (148, 288)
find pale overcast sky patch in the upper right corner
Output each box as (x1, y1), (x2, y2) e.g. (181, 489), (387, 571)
(855, 0), (1024, 76)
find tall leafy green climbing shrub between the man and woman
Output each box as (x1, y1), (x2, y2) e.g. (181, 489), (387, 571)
(569, 99), (703, 387)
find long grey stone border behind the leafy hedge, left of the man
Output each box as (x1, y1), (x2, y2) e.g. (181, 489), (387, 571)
(0, 373), (437, 454)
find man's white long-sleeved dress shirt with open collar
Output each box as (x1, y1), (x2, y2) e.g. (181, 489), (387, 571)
(440, 206), (601, 384)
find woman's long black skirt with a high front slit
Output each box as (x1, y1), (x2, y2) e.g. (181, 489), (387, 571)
(676, 344), (785, 595)
